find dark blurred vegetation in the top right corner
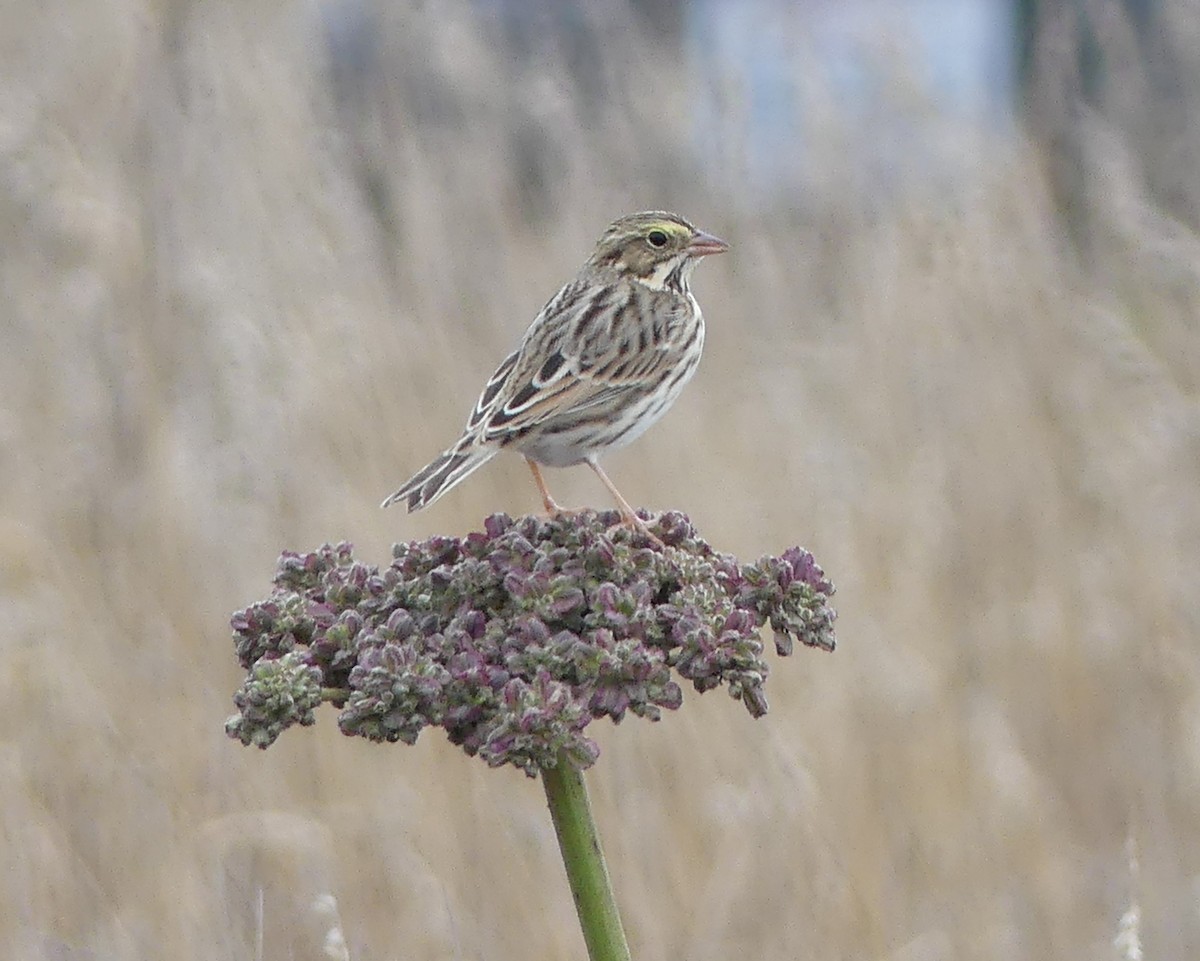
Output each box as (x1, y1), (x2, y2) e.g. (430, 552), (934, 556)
(1014, 0), (1200, 256)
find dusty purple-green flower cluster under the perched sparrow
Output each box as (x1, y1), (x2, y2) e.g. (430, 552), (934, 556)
(226, 511), (834, 775)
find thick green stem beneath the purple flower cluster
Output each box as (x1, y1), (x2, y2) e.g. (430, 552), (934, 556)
(541, 755), (630, 961)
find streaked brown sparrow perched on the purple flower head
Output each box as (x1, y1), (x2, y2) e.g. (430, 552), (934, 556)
(382, 210), (730, 540)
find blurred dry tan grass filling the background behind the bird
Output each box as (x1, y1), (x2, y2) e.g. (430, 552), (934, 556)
(0, 0), (1200, 961)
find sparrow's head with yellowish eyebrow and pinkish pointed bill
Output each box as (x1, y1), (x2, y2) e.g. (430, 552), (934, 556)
(588, 210), (730, 290)
